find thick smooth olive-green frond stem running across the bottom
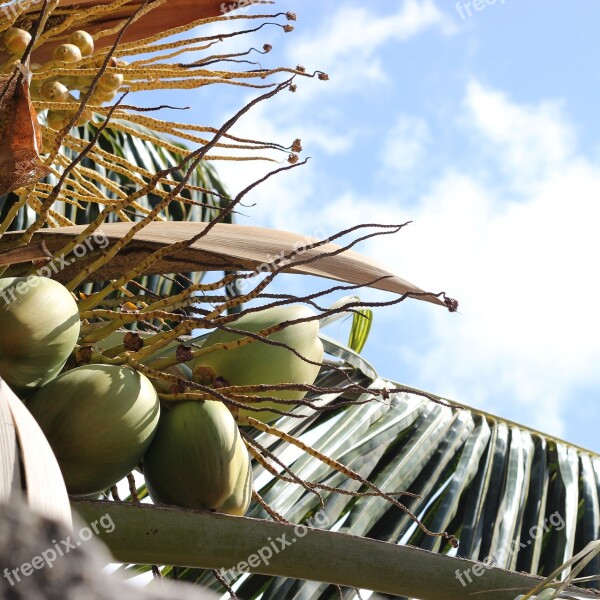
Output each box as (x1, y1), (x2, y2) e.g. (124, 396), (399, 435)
(73, 500), (593, 600)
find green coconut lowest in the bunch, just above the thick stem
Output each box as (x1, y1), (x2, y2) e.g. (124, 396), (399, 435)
(143, 401), (252, 515)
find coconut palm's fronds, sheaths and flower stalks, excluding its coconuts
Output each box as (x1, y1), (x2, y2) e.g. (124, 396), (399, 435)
(0, 0), (600, 600)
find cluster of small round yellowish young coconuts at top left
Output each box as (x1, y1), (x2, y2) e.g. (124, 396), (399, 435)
(2, 27), (126, 131)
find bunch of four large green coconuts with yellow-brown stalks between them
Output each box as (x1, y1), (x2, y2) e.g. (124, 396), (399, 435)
(0, 264), (446, 532)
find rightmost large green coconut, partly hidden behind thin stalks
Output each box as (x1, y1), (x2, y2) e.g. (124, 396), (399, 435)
(192, 305), (323, 423)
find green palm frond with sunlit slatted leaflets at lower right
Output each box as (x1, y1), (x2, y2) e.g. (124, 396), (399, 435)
(136, 337), (600, 600)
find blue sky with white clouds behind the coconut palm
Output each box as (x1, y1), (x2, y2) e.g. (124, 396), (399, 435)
(156, 0), (600, 451)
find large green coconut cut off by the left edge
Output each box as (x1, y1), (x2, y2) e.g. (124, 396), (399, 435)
(0, 275), (79, 391)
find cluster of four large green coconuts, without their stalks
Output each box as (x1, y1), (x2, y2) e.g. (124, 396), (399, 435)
(0, 276), (323, 515)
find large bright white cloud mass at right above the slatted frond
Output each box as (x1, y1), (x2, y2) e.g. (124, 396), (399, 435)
(268, 82), (600, 435)
